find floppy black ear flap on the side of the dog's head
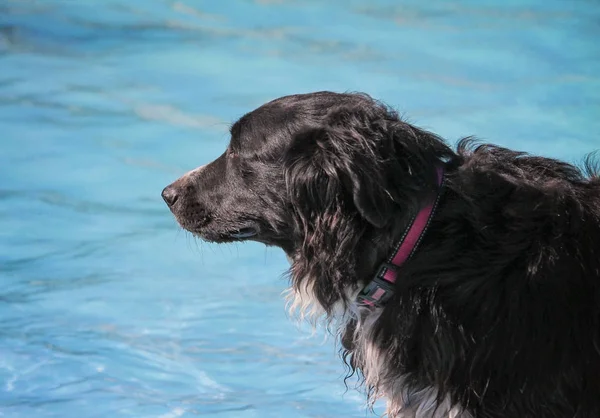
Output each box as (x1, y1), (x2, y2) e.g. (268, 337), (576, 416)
(286, 127), (394, 228)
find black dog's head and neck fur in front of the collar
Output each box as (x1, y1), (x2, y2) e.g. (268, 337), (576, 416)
(163, 92), (451, 311)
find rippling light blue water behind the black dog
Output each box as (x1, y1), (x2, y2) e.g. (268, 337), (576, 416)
(0, 0), (600, 418)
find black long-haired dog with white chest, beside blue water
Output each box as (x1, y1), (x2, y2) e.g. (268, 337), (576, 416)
(162, 92), (600, 418)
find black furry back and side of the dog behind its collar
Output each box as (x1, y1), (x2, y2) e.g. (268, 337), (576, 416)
(404, 141), (600, 418)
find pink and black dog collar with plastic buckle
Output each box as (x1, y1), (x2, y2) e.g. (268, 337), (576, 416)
(357, 167), (444, 307)
